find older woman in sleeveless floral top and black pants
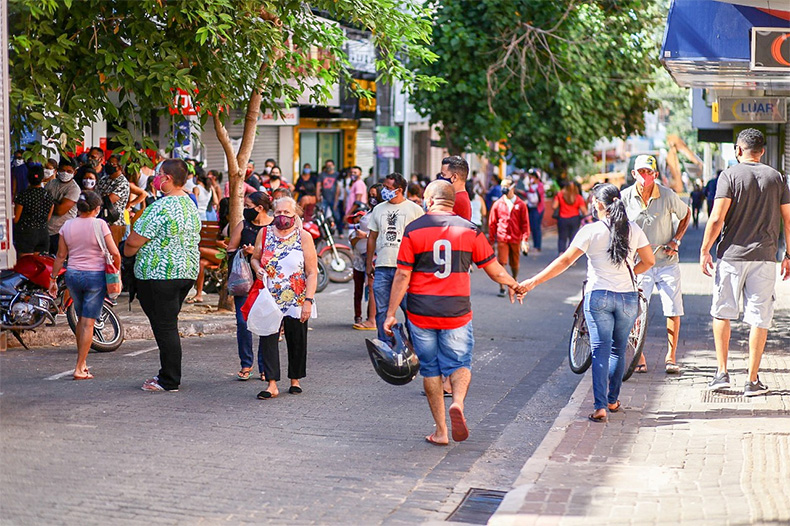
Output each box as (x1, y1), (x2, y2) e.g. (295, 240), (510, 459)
(250, 197), (318, 400)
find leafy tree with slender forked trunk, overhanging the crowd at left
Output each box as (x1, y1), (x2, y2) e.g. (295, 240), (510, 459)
(9, 0), (437, 224)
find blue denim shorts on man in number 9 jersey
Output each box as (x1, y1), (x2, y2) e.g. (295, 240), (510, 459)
(409, 321), (475, 378)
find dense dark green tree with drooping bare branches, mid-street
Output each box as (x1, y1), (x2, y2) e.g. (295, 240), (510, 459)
(414, 0), (663, 173)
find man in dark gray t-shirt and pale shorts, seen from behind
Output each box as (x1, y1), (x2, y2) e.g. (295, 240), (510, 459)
(700, 128), (790, 396)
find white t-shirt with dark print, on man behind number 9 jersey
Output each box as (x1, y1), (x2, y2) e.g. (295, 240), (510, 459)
(368, 199), (425, 267)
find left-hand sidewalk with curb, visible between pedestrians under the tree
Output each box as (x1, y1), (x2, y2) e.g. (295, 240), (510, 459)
(8, 294), (236, 348)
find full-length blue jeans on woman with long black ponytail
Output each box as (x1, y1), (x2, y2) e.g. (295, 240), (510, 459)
(584, 290), (639, 411)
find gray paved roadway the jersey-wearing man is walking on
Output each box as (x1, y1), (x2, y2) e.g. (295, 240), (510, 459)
(0, 244), (584, 524)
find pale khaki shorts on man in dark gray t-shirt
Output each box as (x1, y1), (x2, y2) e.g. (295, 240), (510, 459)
(710, 259), (776, 329)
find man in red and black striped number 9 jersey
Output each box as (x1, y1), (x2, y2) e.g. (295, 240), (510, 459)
(384, 181), (519, 446)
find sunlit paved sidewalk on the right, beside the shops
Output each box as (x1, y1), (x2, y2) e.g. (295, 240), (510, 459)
(488, 262), (790, 526)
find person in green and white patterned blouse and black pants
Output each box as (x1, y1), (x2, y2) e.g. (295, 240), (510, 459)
(124, 159), (200, 391)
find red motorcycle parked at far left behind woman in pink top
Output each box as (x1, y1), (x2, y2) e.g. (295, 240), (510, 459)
(0, 254), (124, 352)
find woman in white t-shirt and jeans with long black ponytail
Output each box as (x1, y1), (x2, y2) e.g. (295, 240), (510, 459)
(522, 183), (655, 422)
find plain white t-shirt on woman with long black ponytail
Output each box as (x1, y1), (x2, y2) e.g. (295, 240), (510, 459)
(571, 221), (650, 292)
